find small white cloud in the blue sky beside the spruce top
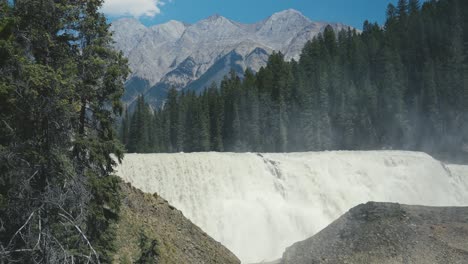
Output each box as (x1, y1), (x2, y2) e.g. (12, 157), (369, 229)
(101, 0), (164, 17)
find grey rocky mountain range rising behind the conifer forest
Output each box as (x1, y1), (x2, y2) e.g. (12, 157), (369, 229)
(111, 9), (348, 108)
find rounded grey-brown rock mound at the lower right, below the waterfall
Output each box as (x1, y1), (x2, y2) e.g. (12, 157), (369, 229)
(280, 203), (468, 264)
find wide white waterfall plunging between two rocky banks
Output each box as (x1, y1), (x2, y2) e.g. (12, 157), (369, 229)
(114, 151), (468, 263)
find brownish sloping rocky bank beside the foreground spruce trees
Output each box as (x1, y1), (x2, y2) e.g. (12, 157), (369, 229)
(114, 184), (240, 264)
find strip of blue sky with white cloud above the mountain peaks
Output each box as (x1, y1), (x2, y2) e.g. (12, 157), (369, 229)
(103, 0), (428, 28)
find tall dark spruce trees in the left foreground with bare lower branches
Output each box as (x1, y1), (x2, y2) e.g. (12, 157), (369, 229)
(0, 0), (128, 263)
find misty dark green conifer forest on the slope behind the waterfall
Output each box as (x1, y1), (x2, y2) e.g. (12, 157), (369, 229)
(120, 0), (468, 159)
